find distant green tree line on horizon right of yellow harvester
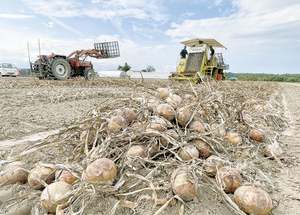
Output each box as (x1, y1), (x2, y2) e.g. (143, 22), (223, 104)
(226, 72), (300, 82)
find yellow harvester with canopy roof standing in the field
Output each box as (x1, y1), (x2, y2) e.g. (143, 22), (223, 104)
(169, 38), (229, 83)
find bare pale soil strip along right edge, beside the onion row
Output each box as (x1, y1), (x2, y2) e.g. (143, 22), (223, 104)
(271, 83), (300, 215)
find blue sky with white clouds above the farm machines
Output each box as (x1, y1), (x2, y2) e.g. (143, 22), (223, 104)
(0, 0), (300, 74)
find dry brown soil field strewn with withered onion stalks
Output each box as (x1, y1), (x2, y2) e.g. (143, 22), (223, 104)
(0, 78), (300, 215)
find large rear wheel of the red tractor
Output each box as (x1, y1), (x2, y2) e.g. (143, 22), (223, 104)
(51, 58), (71, 80)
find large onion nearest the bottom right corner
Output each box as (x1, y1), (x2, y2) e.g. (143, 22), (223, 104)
(234, 186), (273, 215)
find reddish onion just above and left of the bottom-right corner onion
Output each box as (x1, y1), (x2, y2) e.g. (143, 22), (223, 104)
(216, 167), (243, 193)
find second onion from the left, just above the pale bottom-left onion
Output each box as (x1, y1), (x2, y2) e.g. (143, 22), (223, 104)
(28, 166), (55, 190)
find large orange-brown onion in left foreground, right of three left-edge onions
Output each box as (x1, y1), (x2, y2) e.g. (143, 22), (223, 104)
(85, 158), (117, 184)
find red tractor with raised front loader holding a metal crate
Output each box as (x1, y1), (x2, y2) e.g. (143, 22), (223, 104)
(30, 42), (120, 80)
